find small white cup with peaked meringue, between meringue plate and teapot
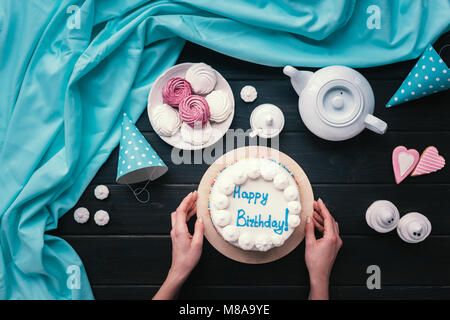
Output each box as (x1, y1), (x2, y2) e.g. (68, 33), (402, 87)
(250, 103), (284, 138)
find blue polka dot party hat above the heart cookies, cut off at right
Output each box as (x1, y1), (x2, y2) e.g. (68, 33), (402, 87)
(386, 45), (450, 108)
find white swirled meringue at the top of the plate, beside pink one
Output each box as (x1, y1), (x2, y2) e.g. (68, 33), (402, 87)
(185, 63), (217, 95)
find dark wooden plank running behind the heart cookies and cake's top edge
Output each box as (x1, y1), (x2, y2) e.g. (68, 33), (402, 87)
(93, 131), (450, 187)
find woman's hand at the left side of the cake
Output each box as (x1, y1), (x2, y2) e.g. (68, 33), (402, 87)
(153, 191), (203, 300)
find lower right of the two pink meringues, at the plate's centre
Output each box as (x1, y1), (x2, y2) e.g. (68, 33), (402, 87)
(178, 95), (211, 128)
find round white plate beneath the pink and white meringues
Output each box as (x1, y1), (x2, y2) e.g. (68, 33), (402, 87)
(147, 62), (234, 150)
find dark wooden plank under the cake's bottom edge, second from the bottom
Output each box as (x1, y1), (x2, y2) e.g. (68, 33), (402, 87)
(64, 233), (450, 286)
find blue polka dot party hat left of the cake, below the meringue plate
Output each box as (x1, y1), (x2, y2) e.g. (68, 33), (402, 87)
(116, 113), (168, 184)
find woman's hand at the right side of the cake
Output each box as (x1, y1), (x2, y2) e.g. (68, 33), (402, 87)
(305, 199), (342, 300)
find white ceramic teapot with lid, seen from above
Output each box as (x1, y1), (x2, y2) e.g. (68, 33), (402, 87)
(283, 66), (387, 141)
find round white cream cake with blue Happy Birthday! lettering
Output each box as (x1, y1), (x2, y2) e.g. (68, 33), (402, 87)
(208, 158), (301, 251)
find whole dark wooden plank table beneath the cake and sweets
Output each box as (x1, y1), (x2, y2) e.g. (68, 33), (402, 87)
(54, 35), (450, 299)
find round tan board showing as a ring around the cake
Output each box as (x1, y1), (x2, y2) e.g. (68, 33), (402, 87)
(197, 146), (314, 264)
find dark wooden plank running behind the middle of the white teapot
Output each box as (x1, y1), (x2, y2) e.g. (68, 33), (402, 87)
(137, 79), (450, 132)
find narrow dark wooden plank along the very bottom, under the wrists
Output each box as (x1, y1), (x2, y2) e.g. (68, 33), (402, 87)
(92, 285), (450, 300)
